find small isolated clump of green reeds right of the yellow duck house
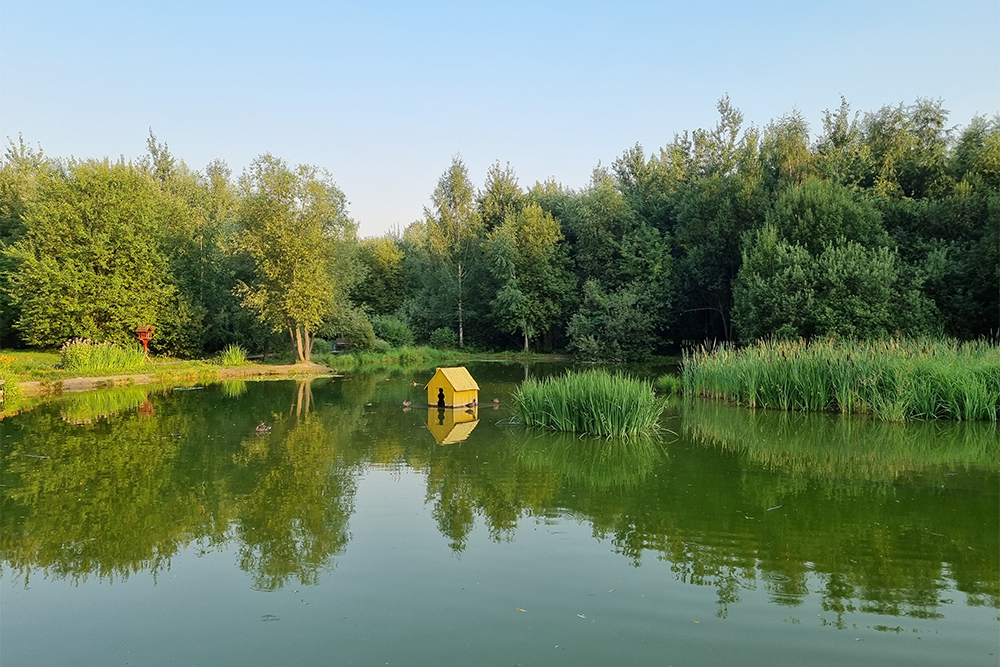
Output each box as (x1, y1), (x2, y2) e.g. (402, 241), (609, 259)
(512, 370), (663, 438)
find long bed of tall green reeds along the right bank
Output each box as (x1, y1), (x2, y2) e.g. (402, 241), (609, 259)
(682, 339), (1000, 422)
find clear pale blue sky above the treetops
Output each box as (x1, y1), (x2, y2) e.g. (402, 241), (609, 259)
(0, 0), (1000, 236)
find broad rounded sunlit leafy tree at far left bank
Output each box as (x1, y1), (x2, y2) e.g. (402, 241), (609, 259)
(5, 162), (175, 347)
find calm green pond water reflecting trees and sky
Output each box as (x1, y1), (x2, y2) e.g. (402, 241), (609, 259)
(0, 364), (1000, 667)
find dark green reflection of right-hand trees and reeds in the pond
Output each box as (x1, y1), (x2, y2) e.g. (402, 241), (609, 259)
(567, 404), (1000, 625)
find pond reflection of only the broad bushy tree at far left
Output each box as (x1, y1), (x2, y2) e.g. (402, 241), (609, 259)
(0, 406), (205, 583)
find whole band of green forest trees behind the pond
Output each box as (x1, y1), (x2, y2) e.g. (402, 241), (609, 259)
(0, 97), (1000, 361)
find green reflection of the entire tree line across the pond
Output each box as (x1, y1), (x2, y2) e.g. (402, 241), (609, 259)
(0, 365), (1000, 627)
